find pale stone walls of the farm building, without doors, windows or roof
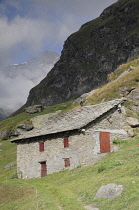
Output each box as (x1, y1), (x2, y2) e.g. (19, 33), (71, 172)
(17, 104), (128, 178)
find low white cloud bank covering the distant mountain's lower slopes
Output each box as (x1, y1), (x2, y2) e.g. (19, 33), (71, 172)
(0, 61), (53, 112)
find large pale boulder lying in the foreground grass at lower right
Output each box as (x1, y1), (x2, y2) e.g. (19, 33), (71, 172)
(94, 183), (123, 200)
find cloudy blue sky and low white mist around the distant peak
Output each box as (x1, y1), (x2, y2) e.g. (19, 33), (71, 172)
(0, 0), (117, 111)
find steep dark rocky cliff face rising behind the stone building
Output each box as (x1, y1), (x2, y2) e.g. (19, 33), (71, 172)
(25, 0), (139, 106)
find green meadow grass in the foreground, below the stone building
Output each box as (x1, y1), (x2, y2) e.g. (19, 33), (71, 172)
(0, 137), (139, 210)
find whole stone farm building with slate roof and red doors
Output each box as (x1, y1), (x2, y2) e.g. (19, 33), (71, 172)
(12, 99), (128, 178)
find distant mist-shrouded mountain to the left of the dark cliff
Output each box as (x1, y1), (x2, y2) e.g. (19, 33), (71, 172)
(0, 51), (59, 116)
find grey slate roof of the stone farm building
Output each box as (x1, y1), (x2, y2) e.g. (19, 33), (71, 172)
(11, 99), (126, 142)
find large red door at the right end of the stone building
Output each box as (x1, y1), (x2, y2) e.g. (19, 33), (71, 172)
(99, 132), (110, 153)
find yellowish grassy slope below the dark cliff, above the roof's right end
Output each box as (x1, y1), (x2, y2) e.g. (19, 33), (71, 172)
(86, 59), (139, 105)
